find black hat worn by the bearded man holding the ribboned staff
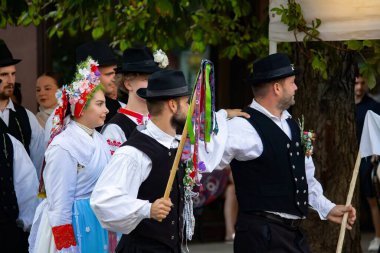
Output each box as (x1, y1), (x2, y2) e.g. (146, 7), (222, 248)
(137, 69), (191, 99)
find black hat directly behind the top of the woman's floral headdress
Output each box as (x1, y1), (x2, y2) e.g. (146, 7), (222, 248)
(75, 40), (117, 67)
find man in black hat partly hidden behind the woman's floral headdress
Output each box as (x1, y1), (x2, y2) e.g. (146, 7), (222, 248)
(76, 41), (124, 131)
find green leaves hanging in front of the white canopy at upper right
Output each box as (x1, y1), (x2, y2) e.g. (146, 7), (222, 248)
(271, 0), (380, 88)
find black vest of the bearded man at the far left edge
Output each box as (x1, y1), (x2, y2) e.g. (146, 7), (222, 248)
(0, 104), (32, 154)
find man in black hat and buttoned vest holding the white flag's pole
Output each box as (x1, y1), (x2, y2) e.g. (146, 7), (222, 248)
(203, 53), (356, 253)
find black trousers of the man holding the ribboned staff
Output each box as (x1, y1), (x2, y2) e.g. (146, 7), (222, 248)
(115, 231), (181, 253)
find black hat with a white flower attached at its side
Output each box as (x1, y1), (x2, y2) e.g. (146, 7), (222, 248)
(116, 47), (161, 74)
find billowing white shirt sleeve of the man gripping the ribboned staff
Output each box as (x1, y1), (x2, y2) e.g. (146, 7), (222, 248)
(90, 146), (152, 234)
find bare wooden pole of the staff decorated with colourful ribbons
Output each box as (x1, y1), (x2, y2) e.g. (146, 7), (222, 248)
(164, 92), (195, 199)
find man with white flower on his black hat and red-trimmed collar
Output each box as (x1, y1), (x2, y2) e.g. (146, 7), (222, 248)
(102, 47), (168, 153)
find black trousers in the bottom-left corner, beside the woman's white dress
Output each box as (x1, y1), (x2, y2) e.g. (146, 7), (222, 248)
(0, 221), (29, 253)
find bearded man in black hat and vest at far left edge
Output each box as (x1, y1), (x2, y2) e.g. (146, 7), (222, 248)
(0, 40), (45, 172)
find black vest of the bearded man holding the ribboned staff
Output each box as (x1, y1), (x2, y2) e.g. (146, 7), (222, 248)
(123, 130), (184, 249)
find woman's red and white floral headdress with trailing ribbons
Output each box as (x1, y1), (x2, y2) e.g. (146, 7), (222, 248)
(39, 57), (102, 197)
